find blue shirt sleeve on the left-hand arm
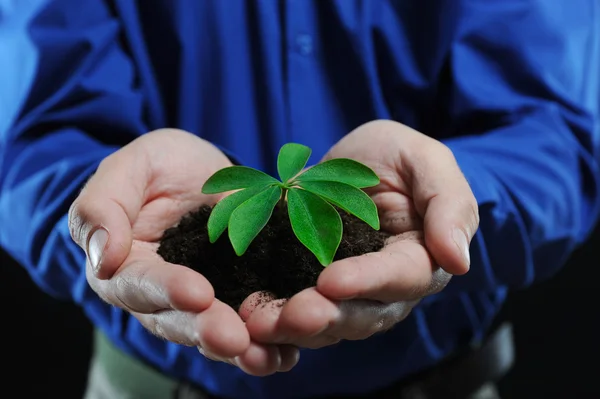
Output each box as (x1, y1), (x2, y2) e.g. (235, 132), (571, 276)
(0, 0), (199, 376)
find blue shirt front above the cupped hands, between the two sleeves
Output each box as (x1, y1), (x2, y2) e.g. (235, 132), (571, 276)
(116, 0), (457, 171)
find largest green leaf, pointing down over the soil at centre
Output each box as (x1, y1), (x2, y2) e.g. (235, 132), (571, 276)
(288, 188), (343, 266)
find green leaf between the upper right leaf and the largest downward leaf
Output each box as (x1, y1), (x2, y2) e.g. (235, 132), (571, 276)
(300, 181), (379, 230)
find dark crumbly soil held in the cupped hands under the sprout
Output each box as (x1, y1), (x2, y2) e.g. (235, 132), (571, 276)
(158, 206), (389, 310)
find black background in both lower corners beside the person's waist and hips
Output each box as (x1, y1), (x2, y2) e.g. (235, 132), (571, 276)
(0, 225), (600, 399)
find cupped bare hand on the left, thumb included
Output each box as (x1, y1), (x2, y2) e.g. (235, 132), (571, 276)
(69, 129), (299, 375)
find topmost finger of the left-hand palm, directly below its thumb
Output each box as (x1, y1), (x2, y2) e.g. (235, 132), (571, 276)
(86, 243), (214, 313)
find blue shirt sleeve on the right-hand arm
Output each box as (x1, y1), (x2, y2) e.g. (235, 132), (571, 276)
(444, 0), (600, 294)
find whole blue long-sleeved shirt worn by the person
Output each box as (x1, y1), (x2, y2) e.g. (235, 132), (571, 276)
(0, 0), (600, 398)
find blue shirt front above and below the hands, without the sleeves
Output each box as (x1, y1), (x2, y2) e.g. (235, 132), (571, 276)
(106, 0), (502, 398)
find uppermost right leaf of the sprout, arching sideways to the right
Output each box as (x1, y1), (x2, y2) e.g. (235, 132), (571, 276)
(296, 158), (379, 188)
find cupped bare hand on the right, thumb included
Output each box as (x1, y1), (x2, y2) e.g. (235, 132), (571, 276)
(240, 121), (479, 348)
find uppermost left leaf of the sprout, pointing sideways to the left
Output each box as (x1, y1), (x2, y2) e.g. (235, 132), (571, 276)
(202, 166), (279, 194)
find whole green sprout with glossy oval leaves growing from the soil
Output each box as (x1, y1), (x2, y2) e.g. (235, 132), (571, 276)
(202, 143), (379, 266)
